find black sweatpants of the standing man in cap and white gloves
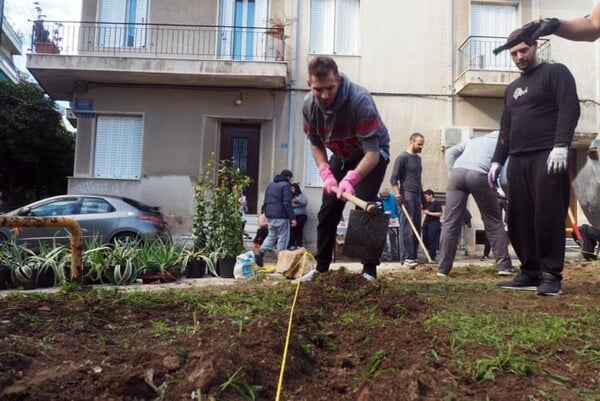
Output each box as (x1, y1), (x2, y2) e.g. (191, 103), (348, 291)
(507, 150), (571, 279)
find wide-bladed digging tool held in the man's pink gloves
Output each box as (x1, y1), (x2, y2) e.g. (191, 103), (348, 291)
(332, 187), (390, 259)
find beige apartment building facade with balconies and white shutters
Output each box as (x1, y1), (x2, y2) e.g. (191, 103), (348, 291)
(27, 0), (600, 250)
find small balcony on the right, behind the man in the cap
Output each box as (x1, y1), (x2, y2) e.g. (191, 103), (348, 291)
(454, 36), (550, 98)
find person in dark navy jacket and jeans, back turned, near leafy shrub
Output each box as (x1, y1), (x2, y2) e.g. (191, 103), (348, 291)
(254, 170), (296, 267)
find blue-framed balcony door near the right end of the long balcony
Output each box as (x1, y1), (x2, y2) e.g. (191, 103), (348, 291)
(219, 0), (269, 60)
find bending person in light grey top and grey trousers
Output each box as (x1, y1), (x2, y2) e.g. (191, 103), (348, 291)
(438, 131), (516, 277)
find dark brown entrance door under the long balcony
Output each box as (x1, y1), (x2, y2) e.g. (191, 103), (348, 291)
(219, 123), (260, 214)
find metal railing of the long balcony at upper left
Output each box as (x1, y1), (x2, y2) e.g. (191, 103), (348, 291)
(31, 21), (285, 61)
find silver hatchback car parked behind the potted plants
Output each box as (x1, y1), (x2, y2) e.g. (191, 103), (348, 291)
(0, 195), (171, 247)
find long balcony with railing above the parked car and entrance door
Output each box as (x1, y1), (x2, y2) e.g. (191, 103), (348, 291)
(27, 21), (287, 100)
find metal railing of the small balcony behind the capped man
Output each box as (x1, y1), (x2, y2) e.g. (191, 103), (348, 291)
(456, 36), (550, 76)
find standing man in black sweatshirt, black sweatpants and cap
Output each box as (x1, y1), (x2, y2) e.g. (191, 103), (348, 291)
(488, 29), (580, 295)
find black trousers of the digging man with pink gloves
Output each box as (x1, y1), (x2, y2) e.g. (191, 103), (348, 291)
(315, 155), (389, 277)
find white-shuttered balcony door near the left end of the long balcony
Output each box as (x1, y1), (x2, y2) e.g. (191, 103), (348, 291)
(98, 0), (148, 47)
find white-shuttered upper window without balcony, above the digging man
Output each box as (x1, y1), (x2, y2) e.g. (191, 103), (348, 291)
(310, 0), (360, 54)
